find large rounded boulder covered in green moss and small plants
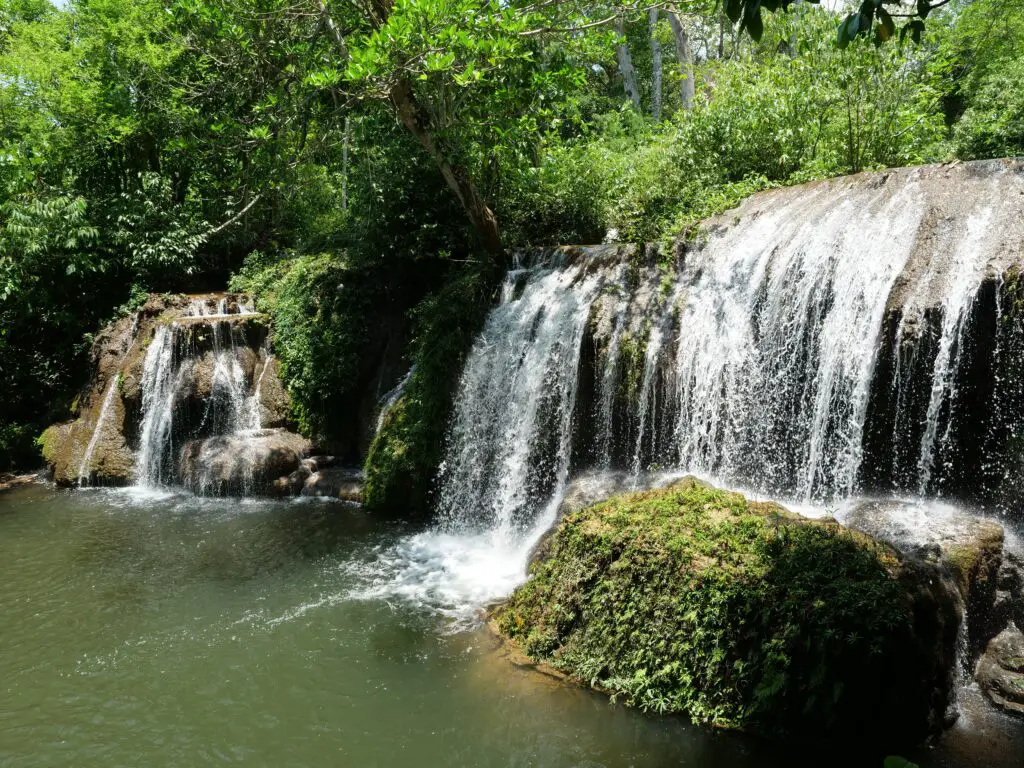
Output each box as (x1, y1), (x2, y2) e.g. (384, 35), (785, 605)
(495, 478), (961, 746)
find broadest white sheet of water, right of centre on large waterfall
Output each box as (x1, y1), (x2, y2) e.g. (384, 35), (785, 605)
(676, 183), (924, 499)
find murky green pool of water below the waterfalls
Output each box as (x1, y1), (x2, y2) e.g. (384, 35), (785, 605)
(0, 486), (1024, 768)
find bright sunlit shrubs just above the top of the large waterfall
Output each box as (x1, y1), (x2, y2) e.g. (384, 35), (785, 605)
(524, 12), (943, 242)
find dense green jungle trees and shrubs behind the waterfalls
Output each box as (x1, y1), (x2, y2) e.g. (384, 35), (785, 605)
(0, 0), (1024, 471)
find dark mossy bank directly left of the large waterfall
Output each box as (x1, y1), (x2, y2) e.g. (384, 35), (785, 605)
(365, 267), (498, 516)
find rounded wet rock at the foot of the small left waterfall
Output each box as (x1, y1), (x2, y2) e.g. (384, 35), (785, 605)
(180, 429), (310, 495)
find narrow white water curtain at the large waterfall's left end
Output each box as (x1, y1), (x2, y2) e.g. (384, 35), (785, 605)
(438, 252), (608, 541)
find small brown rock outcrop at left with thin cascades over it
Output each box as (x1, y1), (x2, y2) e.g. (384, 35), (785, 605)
(41, 294), (311, 495)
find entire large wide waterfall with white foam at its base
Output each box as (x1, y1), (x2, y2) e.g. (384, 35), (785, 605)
(352, 159), (1024, 615)
